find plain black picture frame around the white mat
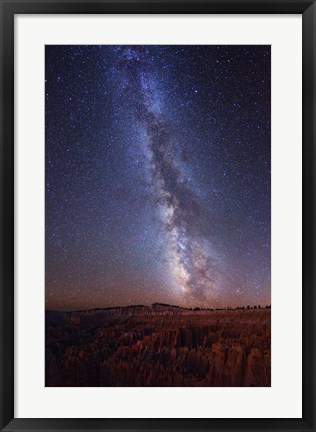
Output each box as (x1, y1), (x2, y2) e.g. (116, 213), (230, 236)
(0, 0), (316, 432)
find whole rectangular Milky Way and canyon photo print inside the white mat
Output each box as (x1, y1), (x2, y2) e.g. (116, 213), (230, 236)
(45, 45), (271, 387)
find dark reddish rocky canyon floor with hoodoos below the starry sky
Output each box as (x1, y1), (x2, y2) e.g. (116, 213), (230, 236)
(45, 305), (271, 387)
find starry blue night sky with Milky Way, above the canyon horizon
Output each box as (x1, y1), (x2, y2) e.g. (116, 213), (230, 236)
(45, 45), (271, 310)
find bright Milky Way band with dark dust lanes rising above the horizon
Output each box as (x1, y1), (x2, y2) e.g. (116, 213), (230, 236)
(118, 48), (223, 300)
